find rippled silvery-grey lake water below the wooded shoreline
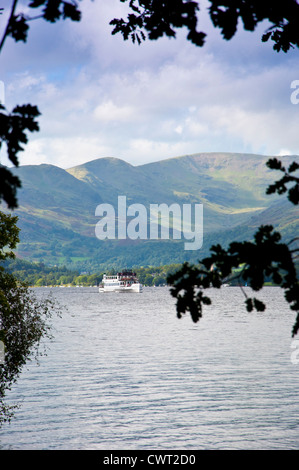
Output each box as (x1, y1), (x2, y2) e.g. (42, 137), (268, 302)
(0, 287), (299, 450)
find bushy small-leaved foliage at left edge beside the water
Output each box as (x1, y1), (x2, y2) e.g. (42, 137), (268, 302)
(0, 212), (59, 426)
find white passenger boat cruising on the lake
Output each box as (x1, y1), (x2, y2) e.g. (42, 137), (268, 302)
(99, 270), (142, 292)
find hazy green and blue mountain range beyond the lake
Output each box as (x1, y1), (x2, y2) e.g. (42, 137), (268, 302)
(1, 153), (299, 272)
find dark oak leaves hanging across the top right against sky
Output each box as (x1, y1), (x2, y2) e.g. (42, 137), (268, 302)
(110, 0), (299, 52)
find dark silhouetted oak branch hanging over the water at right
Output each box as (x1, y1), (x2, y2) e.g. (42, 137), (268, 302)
(167, 226), (299, 336)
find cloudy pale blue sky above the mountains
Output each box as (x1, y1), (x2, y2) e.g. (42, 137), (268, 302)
(0, 0), (299, 168)
